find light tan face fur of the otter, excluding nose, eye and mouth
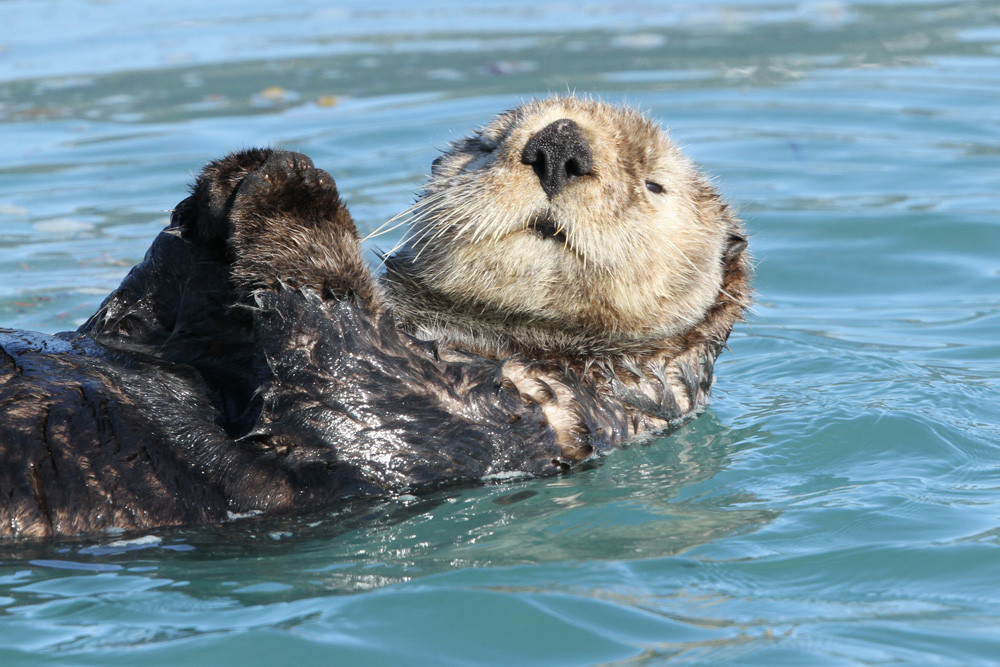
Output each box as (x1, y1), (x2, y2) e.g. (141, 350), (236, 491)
(407, 98), (727, 350)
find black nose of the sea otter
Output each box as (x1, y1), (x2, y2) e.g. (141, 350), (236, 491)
(521, 118), (594, 199)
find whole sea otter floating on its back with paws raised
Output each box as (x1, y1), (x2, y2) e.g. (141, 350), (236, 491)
(0, 98), (750, 537)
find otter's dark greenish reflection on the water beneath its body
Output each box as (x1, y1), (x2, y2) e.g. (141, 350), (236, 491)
(0, 415), (773, 596)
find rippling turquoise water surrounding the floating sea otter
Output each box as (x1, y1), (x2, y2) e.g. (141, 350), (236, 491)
(0, 0), (1000, 665)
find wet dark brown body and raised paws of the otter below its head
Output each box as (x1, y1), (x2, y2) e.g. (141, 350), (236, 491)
(0, 99), (747, 538)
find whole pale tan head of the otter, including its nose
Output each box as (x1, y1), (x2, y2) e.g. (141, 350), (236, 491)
(385, 98), (738, 357)
